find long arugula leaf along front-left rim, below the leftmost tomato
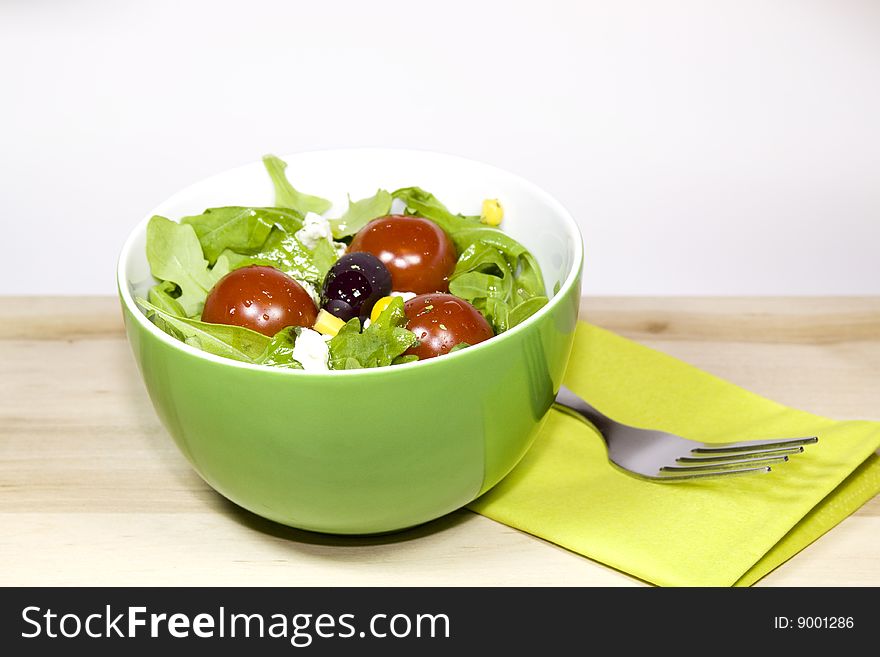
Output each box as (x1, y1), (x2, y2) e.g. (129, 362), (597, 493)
(136, 298), (272, 363)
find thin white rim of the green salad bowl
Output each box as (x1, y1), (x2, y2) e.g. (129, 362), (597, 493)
(116, 147), (584, 378)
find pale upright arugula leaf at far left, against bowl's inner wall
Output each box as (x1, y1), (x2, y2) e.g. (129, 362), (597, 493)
(147, 215), (229, 317)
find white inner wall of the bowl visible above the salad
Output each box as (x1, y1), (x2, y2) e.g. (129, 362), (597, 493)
(118, 149), (582, 338)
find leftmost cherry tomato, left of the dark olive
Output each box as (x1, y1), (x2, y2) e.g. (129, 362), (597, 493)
(202, 265), (318, 336)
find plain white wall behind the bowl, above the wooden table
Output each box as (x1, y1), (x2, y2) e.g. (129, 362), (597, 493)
(0, 0), (880, 295)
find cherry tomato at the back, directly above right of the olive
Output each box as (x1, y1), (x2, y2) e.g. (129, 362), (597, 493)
(348, 214), (458, 294)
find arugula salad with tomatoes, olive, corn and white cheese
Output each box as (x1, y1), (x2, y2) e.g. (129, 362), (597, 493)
(137, 155), (547, 371)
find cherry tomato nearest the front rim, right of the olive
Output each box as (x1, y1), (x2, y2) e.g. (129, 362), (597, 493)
(403, 294), (494, 360)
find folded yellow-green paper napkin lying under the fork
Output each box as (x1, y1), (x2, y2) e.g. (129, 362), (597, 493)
(470, 323), (880, 586)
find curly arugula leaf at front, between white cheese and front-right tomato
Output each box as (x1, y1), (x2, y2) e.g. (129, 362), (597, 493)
(327, 297), (418, 370)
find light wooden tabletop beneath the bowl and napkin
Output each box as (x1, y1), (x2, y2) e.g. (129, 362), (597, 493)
(0, 298), (880, 586)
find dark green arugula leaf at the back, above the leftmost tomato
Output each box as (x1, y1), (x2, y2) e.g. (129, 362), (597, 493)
(180, 206), (303, 264)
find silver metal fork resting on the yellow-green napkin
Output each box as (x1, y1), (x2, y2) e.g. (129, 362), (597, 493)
(556, 386), (819, 482)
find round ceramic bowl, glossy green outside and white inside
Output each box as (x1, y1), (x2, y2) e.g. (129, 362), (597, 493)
(117, 149), (583, 534)
